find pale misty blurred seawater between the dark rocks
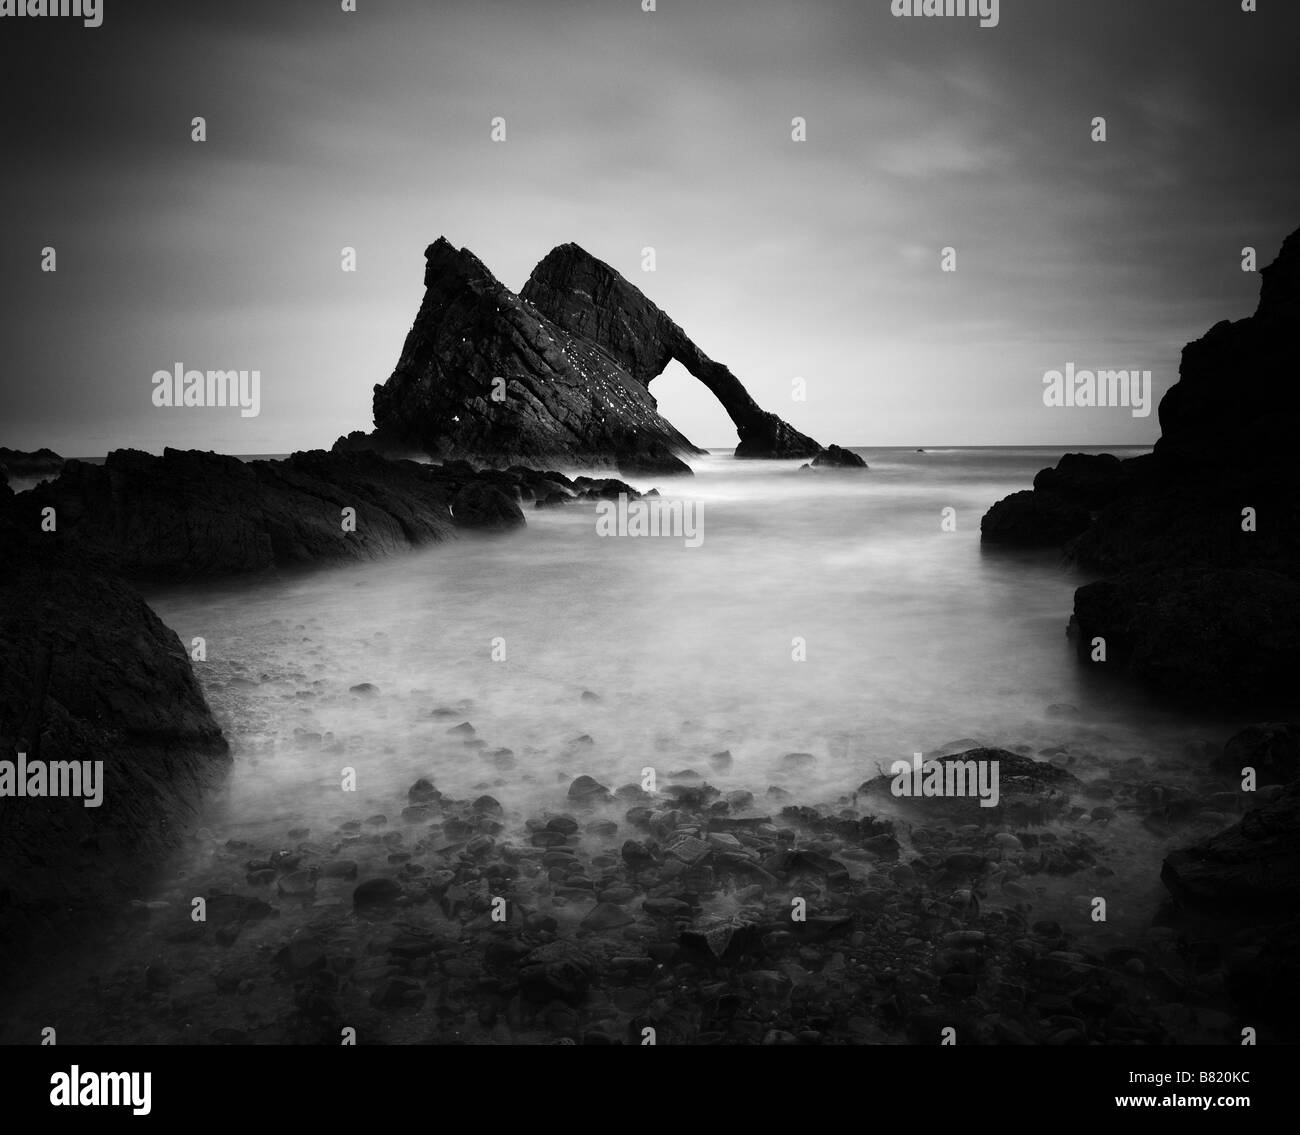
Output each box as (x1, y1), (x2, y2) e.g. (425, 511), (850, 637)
(139, 449), (1240, 930)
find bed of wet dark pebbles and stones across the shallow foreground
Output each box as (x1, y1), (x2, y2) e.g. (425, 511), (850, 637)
(3, 703), (1296, 1045)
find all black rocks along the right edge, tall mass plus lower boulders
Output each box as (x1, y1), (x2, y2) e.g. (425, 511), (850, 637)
(982, 231), (1300, 1029)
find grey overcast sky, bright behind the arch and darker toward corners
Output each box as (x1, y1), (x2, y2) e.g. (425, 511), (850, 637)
(0, 0), (1300, 456)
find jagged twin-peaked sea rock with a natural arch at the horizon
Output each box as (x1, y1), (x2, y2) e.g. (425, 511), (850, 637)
(374, 238), (822, 472)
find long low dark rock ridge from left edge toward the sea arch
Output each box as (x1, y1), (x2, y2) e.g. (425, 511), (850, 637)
(2, 450), (595, 580)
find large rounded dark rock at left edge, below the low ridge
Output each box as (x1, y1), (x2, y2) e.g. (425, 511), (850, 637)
(0, 519), (228, 983)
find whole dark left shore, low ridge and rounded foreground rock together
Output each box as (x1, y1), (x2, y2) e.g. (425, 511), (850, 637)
(0, 450), (641, 984)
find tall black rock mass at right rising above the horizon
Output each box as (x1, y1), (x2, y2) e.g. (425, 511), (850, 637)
(980, 231), (1300, 711)
